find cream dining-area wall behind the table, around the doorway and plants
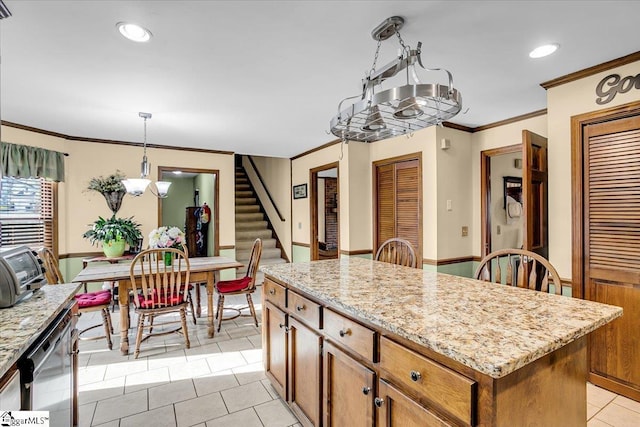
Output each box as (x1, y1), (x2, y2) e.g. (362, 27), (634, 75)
(2, 126), (235, 255)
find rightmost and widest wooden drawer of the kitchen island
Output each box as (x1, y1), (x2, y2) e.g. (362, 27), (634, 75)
(380, 337), (476, 425)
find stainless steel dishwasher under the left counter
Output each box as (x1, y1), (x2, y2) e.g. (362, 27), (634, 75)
(18, 308), (77, 427)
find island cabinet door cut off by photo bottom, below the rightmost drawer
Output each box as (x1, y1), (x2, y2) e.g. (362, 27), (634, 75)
(375, 380), (450, 427)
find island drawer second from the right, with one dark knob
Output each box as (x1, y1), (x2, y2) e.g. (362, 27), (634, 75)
(324, 309), (376, 362)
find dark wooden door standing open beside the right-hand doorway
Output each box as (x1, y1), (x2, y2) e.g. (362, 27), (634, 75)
(522, 130), (549, 258)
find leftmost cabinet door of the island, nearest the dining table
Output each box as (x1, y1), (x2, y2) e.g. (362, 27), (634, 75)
(262, 301), (287, 400)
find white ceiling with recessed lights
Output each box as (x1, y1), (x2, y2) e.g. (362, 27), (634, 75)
(0, 0), (640, 157)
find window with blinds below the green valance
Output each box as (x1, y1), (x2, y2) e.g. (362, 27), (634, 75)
(0, 176), (58, 253)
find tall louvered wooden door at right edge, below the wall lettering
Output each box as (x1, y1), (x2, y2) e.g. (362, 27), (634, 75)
(583, 117), (640, 400)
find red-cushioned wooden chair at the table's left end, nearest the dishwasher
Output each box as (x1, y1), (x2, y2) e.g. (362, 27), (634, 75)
(38, 248), (113, 350)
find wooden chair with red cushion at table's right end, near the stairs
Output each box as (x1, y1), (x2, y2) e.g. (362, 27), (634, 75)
(215, 239), (262, 332)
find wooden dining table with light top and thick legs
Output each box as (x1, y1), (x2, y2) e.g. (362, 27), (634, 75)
(72, 256), (243, 355)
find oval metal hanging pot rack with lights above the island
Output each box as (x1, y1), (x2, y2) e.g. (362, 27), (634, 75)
(330, 16), (462, 142)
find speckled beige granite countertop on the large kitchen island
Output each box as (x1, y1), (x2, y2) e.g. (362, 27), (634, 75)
(261, 257), (622, 378)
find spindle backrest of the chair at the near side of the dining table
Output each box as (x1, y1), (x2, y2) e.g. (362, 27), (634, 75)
(129, 248), (190, 309)
